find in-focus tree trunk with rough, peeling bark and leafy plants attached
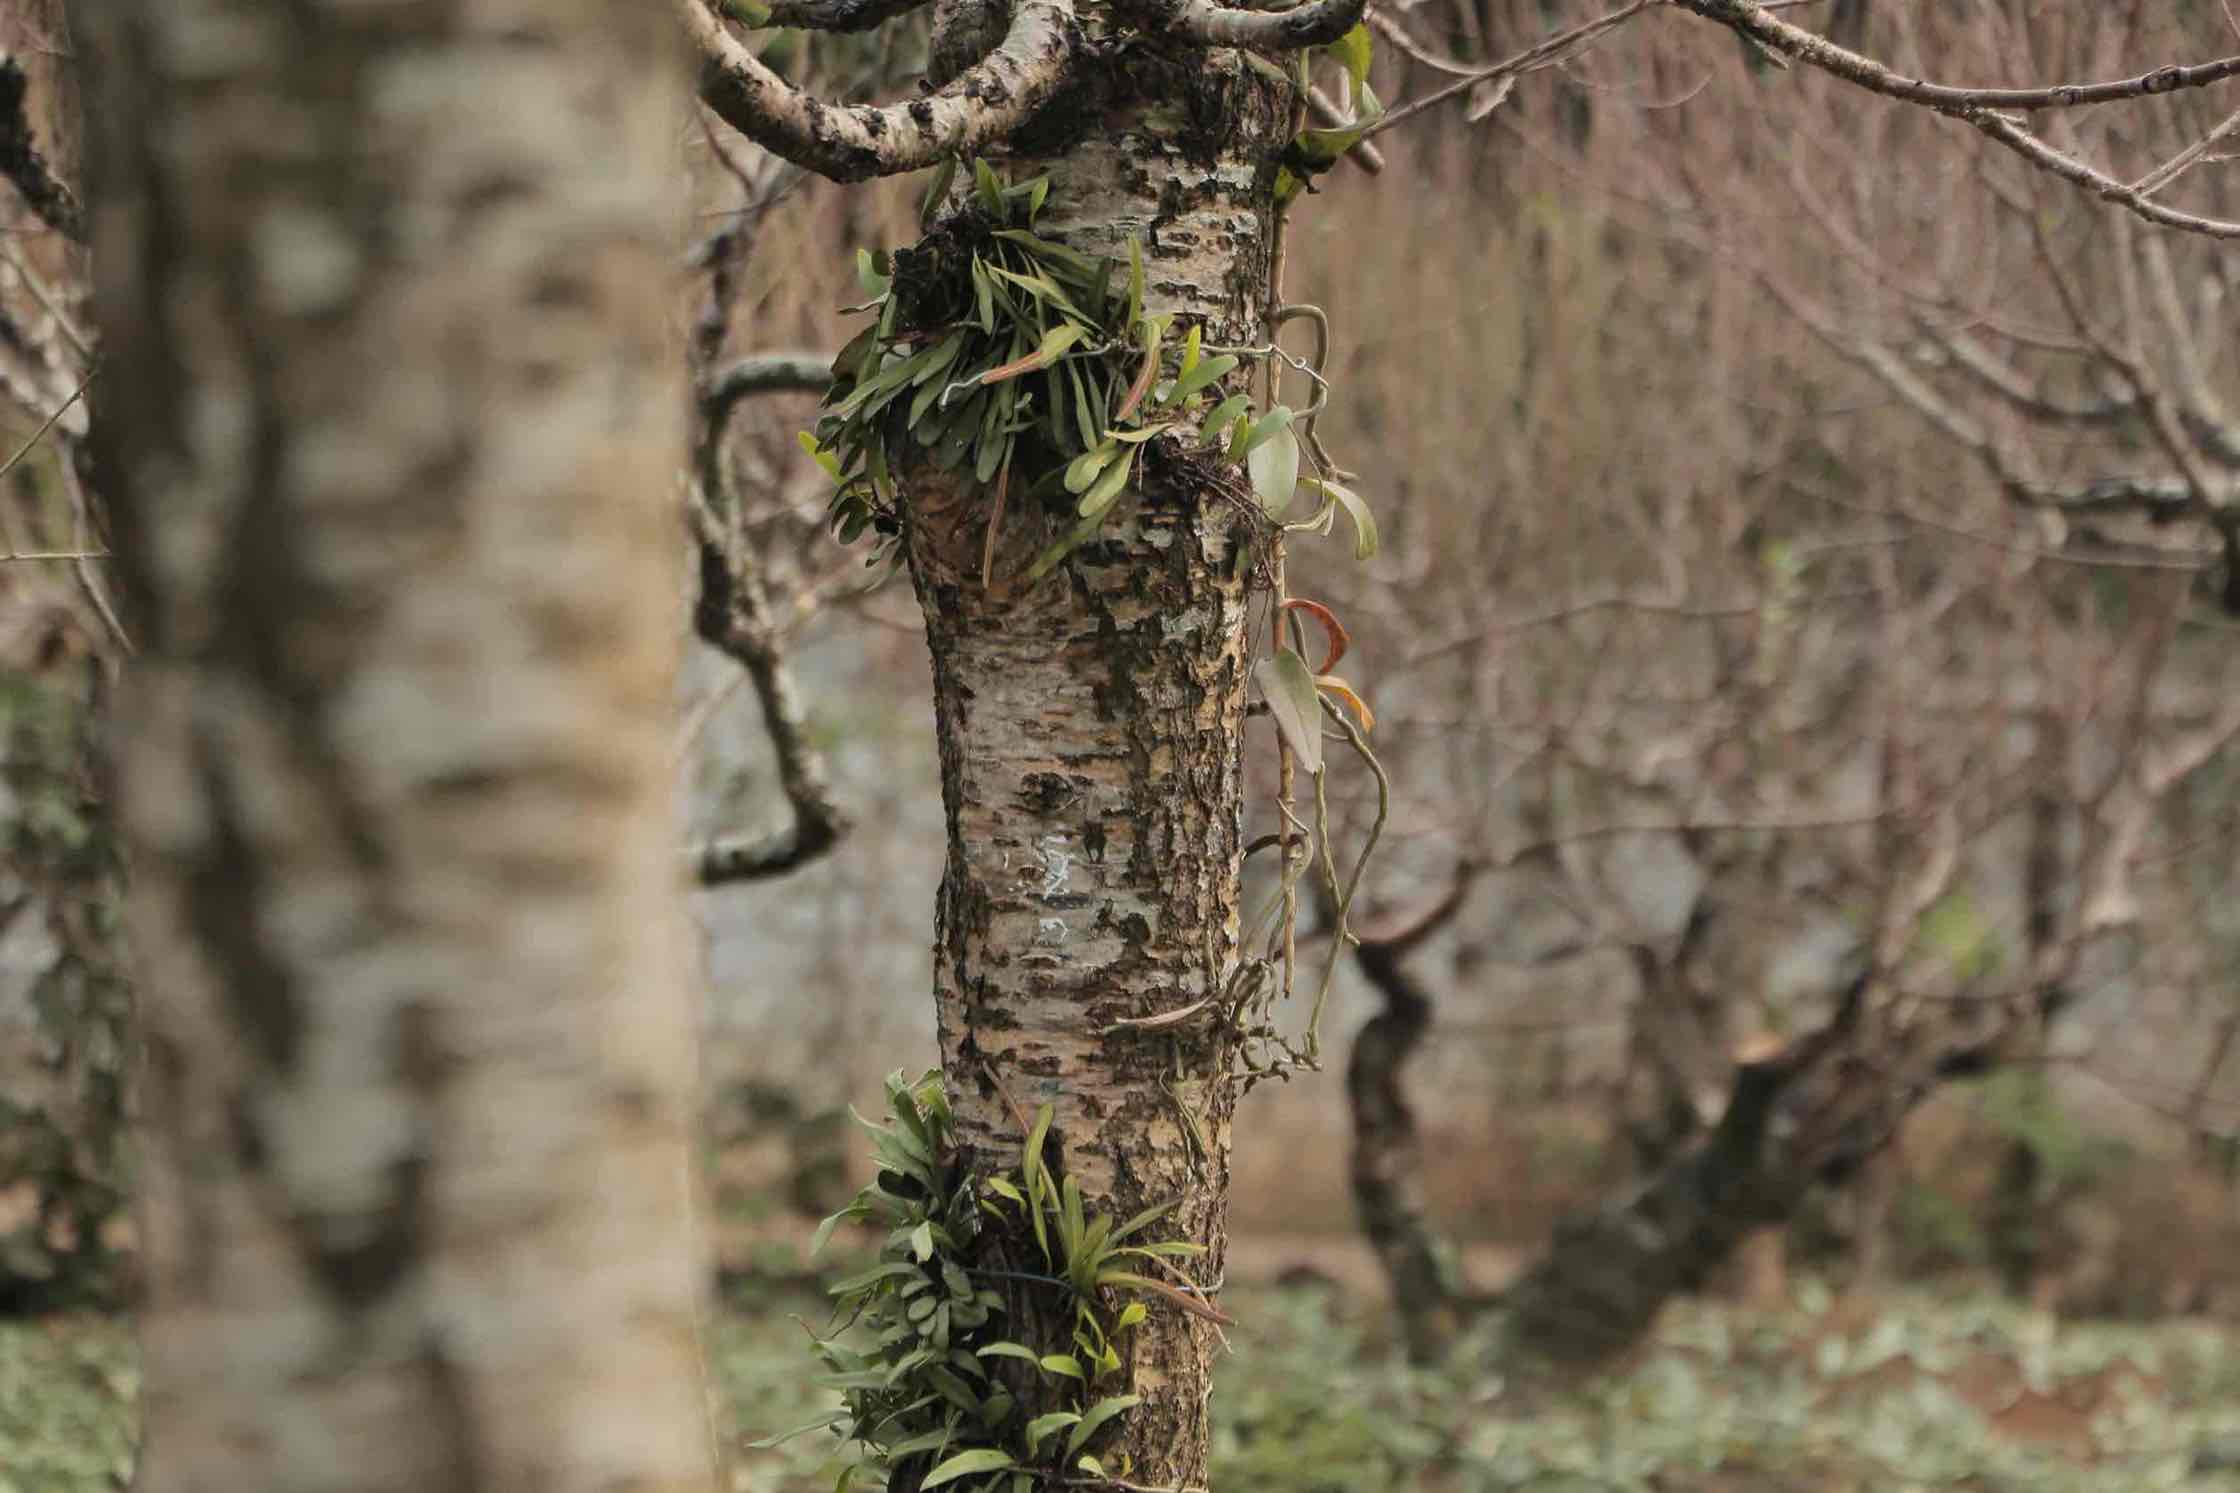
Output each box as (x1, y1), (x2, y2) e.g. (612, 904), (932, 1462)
(905, 54), (1288, 1486)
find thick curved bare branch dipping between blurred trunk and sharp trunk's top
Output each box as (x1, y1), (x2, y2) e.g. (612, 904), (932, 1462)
(676, 0), (1077, 181)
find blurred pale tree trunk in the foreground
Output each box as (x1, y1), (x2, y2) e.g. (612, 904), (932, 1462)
(87, 0), (710, 1493)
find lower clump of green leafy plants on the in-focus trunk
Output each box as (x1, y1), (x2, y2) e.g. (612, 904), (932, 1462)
(755, 1072), (1214, 1493)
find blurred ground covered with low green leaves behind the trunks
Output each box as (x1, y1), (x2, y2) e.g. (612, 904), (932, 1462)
(13, 1283), (2240, 1493)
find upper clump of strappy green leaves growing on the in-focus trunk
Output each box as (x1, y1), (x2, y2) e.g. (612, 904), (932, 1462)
(802, 161), (1337, 580)
